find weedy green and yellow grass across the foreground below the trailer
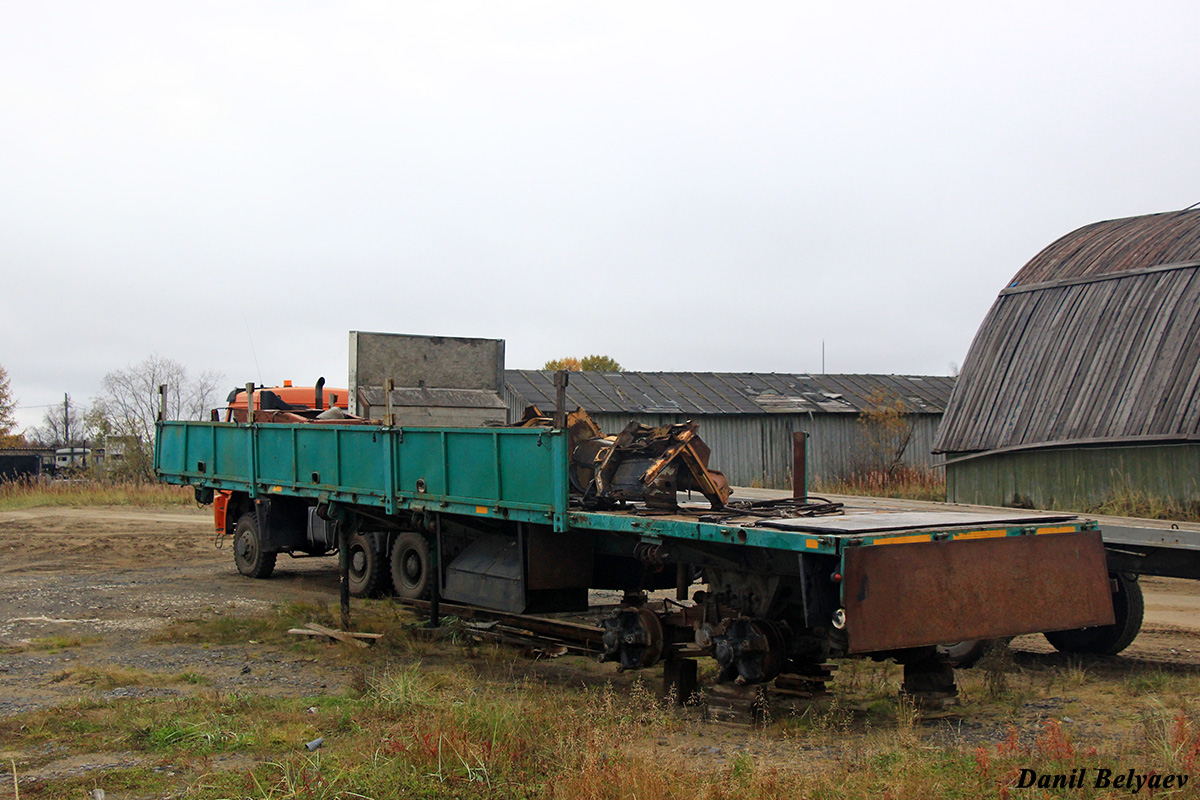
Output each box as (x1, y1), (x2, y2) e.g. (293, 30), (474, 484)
(11, 602), (1200, 800)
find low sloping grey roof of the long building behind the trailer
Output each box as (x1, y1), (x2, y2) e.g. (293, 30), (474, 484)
(504, 369), (954, 415)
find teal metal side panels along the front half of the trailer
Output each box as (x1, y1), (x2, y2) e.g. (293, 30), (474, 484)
(155, 421), (568, 530)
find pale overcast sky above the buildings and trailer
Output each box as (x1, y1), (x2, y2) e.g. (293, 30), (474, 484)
(0, 0), (1200, 434)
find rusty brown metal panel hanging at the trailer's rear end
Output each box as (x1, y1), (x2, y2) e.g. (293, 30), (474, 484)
(842, 531), (1114, 652)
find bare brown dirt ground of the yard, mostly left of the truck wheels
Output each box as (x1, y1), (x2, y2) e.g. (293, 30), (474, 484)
(0, 509), (1200, 791)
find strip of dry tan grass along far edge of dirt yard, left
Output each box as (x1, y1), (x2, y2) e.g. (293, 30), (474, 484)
(0, 479), (196, 511)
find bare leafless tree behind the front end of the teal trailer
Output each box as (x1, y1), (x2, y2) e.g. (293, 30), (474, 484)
(89, 355), (223, 480)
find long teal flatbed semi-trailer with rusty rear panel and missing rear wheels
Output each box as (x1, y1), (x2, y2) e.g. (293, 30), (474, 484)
(155, 421), (1115, 691)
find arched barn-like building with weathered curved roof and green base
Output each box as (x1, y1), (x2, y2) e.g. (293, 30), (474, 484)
(935, 211), (1200, 509)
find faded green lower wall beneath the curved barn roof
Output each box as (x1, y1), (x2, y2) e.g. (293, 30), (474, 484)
(946, 444), (1200, 510)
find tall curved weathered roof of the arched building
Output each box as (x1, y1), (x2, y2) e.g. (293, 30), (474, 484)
(935, 211), (1200, 453)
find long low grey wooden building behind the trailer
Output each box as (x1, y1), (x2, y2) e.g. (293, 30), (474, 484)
(504, 369), (954, 489)
